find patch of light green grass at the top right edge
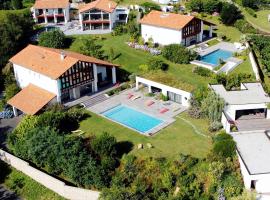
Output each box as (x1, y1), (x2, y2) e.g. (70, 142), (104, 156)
(242, 9), (270, 33)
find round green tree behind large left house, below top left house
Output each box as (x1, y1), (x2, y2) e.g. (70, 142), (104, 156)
(38, 30), (66, 49)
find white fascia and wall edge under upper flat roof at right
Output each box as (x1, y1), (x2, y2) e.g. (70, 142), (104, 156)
(224, 103), (267, 120)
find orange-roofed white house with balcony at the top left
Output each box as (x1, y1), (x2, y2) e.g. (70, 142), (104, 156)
(32, 0), (70, 24)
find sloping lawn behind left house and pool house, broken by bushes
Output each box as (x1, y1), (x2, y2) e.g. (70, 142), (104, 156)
(70, 34), (213, 87)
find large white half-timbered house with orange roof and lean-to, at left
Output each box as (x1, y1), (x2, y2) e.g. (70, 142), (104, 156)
(8, 45), (117, 115)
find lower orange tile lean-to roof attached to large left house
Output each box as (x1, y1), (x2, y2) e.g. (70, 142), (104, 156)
(8, 84), (56, 115)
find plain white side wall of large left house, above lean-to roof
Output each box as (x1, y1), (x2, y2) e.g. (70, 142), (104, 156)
(13, 64), (60, 96)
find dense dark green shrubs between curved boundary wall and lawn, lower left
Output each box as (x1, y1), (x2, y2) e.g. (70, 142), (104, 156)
(9, 106), (117, 188)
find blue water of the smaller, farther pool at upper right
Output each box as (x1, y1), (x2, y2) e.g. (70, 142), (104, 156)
(200, 49), (233, 65)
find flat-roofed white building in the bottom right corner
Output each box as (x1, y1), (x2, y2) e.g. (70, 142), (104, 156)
(233, 131), (270, 195)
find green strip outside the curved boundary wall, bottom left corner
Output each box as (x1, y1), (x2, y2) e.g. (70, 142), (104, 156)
(3, 168), (64, 200)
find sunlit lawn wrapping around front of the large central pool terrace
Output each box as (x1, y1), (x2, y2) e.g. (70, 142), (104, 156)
(80, 113), (211, 158)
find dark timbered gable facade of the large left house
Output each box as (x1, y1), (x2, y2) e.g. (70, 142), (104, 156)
(59, 61), (94, 92)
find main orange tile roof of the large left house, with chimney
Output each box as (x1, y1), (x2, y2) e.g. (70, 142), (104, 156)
(10, 45), (118, 79)
